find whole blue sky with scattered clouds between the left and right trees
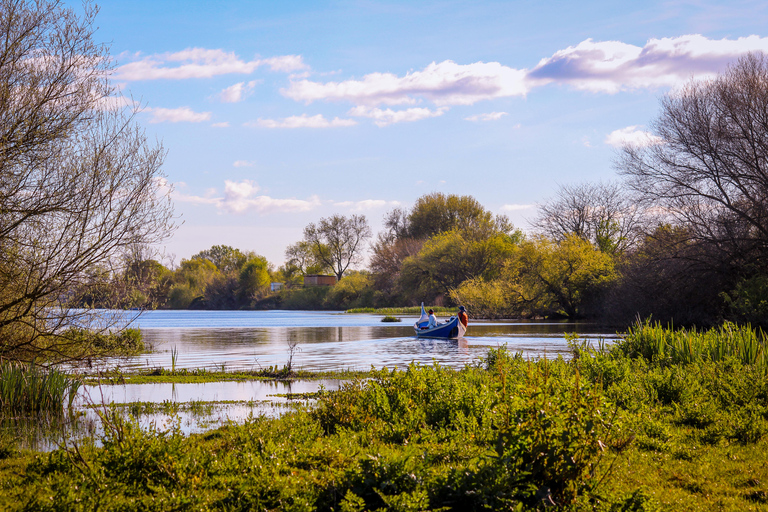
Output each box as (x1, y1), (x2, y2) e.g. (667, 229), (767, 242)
(73, 0), (768, 266)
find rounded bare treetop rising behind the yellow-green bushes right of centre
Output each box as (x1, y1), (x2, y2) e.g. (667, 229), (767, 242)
(532, 183), (643, 253)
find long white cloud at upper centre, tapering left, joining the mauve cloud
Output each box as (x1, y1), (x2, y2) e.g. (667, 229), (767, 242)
(280, 60), (527, 106)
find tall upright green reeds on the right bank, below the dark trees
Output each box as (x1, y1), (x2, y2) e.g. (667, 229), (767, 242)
(619, 320), (768, 370)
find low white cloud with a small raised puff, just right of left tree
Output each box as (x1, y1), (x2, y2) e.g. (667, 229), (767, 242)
(173, 180), (321, 214)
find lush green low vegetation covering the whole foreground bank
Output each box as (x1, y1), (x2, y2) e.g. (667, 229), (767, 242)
(0, 324), (768, 511)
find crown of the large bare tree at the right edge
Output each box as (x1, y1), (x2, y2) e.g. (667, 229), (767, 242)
(617, 53), (768, 264)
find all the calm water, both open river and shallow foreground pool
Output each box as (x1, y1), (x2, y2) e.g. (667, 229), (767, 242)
(9, 311), (616, 450)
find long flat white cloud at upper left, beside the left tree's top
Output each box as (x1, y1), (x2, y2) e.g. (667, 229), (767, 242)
(115, 48), (307, 81)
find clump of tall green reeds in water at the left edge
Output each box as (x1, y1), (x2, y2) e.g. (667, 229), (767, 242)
(0, 361), (82, 414)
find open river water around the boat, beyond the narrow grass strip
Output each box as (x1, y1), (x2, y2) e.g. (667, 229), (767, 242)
(99, 311), (615, 371)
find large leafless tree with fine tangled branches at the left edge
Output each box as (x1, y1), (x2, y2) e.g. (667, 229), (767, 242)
(0, 0), (173, 359)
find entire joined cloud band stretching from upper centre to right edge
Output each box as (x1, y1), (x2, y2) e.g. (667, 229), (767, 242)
(281, 35), (768, 113)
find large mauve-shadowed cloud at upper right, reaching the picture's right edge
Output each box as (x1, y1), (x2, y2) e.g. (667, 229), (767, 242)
(527, 34), (768, 94)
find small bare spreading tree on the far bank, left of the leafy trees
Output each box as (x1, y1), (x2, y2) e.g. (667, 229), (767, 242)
(304, 215), (371, 280)
